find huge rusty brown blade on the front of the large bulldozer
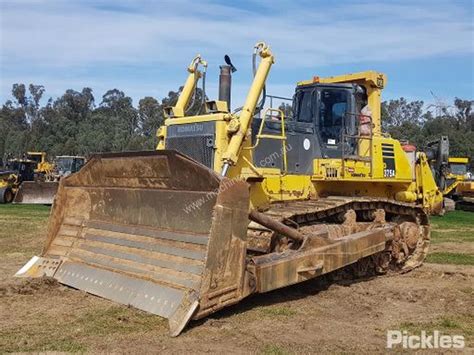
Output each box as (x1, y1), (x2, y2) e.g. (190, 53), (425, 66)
(17, 151), (249, 336)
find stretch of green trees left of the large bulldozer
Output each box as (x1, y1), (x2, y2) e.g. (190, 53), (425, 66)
(0, 84), (202, 157)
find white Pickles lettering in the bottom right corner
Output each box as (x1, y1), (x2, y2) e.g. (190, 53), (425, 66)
(387, 330), (465, 349)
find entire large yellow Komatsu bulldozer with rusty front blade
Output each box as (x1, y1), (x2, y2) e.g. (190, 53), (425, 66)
(17, 42), (442, 336)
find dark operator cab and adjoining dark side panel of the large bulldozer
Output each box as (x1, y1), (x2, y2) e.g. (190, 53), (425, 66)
(252, 83), (367, 174)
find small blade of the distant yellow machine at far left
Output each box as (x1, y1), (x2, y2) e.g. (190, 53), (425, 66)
(13, 181), (59, 205)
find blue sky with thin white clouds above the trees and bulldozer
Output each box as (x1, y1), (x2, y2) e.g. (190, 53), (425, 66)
(0, 0), (474, 106)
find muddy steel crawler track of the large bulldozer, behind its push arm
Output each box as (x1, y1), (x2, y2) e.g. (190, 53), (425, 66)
(249, 196), (430, 276)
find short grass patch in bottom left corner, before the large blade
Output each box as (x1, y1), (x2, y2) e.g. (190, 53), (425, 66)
(0, 306), (166, 352)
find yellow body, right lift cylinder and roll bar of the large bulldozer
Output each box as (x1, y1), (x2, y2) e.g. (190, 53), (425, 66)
(157, 43), (443, 211)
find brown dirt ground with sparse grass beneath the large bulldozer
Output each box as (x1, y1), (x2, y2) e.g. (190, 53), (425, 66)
(0, 209), (474, 354)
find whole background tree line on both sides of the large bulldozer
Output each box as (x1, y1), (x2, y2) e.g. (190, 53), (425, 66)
(0, 84), (474, 166)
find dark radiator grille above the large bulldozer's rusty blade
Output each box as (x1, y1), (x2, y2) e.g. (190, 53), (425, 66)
(166, 135), (214, 169)
